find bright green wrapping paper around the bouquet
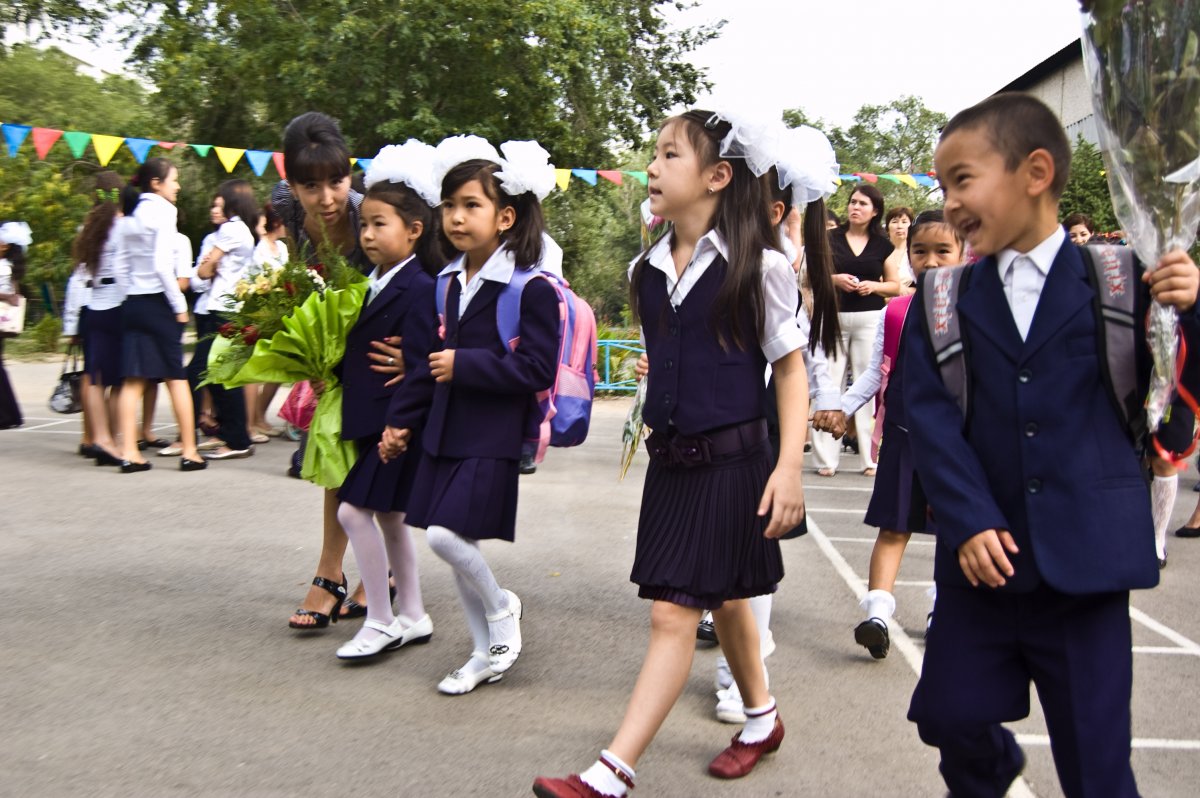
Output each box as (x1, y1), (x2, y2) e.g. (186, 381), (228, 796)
(209, 280), (367, 490)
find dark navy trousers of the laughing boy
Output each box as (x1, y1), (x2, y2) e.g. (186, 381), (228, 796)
(908, 584), (1138, 798)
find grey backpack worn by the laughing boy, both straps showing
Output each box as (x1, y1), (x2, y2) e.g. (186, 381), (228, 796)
(922, 246), (1147, 445)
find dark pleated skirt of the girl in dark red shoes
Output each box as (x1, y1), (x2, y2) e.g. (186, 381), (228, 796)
(629, 440), (784, 610)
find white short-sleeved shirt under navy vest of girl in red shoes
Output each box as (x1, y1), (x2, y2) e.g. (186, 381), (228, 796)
(629, 230), (808, 362)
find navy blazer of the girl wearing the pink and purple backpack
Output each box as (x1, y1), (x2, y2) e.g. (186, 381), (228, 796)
(410, 278), (559, 460)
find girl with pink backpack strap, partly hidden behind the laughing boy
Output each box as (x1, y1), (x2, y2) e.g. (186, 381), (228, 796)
(833, 206), (962, 659)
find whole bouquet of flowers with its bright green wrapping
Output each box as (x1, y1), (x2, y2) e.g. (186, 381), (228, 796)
(205, 256), (367, 490)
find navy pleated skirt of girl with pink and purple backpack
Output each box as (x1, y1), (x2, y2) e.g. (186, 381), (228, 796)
(406, 451), (521, 542)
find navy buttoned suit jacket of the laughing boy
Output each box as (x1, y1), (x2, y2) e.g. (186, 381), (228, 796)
(902, 241), (1200, 594)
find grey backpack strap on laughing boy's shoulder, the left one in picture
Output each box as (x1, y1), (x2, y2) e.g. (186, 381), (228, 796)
(922, 265), (972, 427)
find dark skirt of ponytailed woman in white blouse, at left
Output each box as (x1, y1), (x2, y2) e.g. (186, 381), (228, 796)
(121, 294), (187, 379)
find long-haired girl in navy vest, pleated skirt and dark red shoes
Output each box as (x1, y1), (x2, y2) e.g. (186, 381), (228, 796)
(534, 110), (809, 798)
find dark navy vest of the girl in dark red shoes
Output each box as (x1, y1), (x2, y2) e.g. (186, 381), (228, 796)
(638, 257), (767, 436)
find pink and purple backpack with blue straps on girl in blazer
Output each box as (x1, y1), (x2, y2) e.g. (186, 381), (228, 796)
(437, 268), (596, 463)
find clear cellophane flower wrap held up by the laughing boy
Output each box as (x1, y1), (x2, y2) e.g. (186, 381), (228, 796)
(1081, 0), (1200, 431)
